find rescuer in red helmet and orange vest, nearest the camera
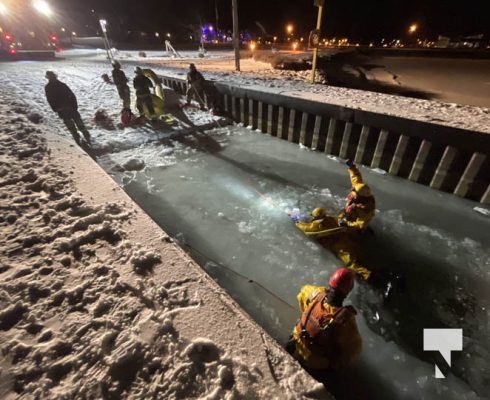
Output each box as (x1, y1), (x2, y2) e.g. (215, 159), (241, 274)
(286, 268), (362, 371)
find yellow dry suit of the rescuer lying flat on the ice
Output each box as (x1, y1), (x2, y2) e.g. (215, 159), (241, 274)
(296, 215), (371, 280)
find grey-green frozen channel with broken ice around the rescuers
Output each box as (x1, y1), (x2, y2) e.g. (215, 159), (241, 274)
(99, 120), (490, 400)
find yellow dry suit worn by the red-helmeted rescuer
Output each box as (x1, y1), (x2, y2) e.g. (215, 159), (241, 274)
(292, 285), (362, 369)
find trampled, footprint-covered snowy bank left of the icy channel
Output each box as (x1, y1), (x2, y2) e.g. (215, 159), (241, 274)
(0, 98), (330, 399)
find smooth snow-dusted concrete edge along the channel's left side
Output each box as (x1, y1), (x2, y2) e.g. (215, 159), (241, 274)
(46, 133), (334, 400)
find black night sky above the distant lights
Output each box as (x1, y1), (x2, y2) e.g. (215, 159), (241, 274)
(51, 0), (490, 41)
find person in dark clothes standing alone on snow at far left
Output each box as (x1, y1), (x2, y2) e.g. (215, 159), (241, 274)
(44, 71), (91, 145)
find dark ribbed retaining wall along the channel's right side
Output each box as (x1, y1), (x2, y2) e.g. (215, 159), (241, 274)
(161, 76), (490, 204)
